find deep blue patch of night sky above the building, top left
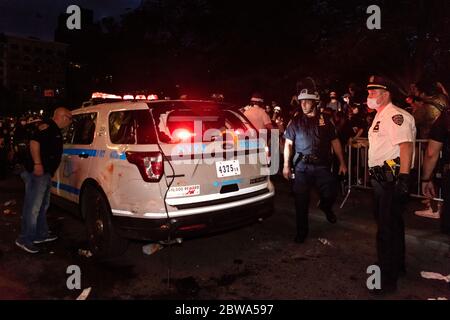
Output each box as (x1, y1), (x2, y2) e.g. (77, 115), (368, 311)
(0, 0), (141, 40)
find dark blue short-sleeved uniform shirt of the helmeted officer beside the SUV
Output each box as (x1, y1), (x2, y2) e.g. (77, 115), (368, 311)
(284, 115), (337, 166)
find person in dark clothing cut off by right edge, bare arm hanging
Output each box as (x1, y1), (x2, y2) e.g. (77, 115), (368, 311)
(422, 108), (450, 234)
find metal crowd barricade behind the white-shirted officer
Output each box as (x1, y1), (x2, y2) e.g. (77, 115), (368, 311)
(340, 138), (443, 209)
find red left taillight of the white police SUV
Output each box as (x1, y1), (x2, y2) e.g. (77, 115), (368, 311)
(126, 151), (164, 182)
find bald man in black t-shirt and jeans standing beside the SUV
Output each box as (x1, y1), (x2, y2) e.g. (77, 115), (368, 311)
(16, 108), (72, 253)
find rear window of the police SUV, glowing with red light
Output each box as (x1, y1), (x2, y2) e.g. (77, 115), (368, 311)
(150, 101), (251, 144)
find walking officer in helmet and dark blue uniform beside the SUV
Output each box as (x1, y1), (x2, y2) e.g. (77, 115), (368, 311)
(283, 89), (347, 243)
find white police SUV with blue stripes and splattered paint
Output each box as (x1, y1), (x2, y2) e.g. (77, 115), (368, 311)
(52, 93), (274, 258)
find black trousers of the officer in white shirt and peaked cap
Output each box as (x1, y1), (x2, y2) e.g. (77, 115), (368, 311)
(371, 179), (407, 285)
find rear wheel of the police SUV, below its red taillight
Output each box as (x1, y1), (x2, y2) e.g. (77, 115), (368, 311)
(81, 185), (128, 260)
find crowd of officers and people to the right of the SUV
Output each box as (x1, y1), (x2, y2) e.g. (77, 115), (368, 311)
(244, 76), (450, 293)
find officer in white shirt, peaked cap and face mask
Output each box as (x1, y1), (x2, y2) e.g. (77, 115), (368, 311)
(367, 76), (416, 293)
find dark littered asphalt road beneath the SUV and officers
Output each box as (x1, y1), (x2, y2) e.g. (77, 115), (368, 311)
(0, 172), (450, 300)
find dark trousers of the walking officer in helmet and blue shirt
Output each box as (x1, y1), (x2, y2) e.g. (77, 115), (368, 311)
(293, 164), (337, 238)
